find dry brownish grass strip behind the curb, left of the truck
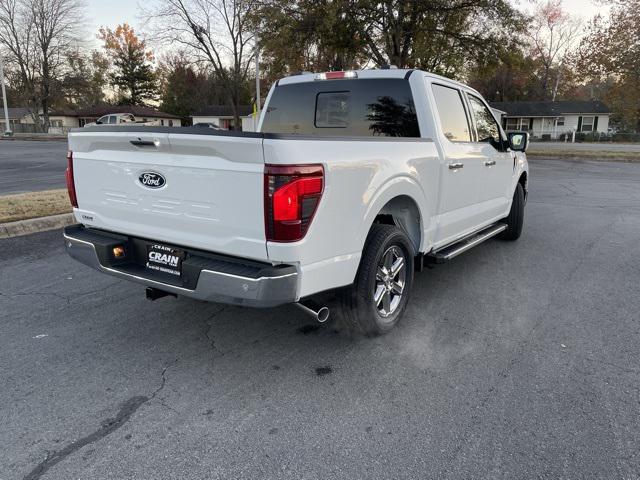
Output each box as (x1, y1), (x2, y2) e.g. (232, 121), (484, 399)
(0, 189), (71, 223)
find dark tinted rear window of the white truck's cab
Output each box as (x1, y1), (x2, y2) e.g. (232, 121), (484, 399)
(262, 79), (420, 137)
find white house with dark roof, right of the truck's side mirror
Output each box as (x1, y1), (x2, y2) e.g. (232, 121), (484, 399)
(490, 100), (611, 140)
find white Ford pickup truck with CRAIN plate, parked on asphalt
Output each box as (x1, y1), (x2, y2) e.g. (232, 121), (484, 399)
(64, 69), (528, 334)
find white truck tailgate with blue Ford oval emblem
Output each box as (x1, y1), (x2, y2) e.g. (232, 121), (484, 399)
(69, 127), (267, 260)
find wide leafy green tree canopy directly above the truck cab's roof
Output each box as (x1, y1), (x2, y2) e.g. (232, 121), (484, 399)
(254, 0), (525, 76)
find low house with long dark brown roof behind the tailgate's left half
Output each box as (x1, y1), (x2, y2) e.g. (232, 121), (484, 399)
(49, 105), (182, 133)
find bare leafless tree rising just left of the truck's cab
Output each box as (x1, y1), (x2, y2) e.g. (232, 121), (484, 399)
(145, 0), (257, 127)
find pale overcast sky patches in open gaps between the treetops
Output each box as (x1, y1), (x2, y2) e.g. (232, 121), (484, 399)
(86, 0), (608, 46)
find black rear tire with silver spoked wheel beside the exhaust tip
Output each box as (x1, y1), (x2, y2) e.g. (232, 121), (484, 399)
(340, 224), (415, 336)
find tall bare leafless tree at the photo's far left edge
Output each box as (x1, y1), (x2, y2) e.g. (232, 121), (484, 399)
(0, 0), (83, 131)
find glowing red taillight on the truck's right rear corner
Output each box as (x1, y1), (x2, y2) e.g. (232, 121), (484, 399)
(264, 165), (324, 242)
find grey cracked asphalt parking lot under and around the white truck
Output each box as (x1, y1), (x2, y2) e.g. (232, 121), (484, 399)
(0, 159), (640, 480)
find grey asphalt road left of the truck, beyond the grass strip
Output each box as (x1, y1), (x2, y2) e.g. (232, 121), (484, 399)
(0, 140), (67, 195)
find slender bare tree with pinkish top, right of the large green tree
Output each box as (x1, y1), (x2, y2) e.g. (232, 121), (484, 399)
(529, 0), (581, 100)
